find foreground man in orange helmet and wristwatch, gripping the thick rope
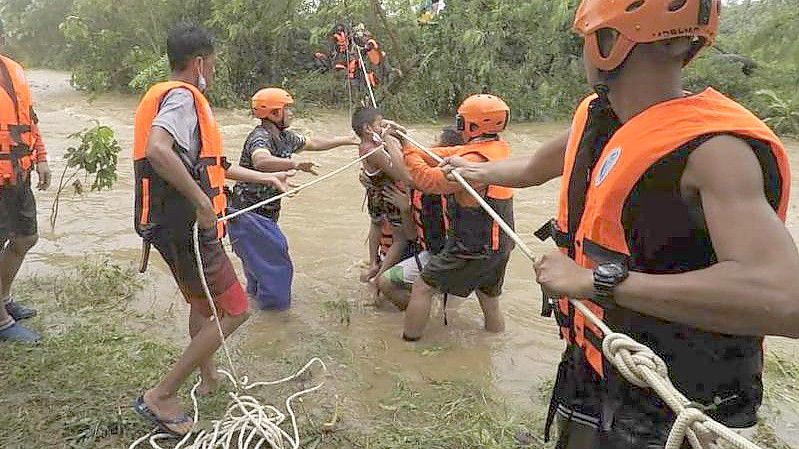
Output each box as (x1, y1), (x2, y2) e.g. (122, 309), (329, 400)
(446, 0), (799, 449)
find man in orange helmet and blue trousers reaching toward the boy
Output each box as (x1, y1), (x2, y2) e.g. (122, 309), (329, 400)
(230, 88), (358, 310)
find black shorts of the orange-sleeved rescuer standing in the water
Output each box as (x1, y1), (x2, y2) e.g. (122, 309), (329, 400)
(421, 245), (510, 297)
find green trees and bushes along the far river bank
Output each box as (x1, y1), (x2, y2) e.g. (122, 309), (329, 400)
(0, 0), (799, 134)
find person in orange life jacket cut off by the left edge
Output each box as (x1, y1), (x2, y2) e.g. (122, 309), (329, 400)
(0, 16), (50, 343)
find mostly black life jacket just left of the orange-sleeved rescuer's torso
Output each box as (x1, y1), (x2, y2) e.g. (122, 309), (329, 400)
(411, 190), (449, 254)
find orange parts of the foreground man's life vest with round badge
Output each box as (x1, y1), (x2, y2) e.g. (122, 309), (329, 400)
(552, 89), (790, 377)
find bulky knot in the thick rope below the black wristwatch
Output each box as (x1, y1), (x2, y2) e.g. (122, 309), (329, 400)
(602, 333), (670, 388)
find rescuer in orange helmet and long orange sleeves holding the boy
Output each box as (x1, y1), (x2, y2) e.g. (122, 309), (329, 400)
(400, 95), (514, 341)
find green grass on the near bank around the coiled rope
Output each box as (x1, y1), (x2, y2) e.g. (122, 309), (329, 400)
(0, 262), (799, 449)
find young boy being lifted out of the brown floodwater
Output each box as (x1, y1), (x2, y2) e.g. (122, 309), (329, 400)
(352, 107), (411, 281)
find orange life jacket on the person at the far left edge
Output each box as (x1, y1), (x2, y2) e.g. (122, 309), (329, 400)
(0, 55), (36, 187)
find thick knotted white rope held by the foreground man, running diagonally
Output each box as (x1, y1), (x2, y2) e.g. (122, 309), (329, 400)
(398, 132), (761, 449)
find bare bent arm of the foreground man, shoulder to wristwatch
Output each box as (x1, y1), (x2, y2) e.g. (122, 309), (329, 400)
(616, 136), (799, 337)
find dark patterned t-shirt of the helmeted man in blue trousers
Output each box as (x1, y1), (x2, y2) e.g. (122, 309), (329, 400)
(232, 125), (305, 221)
